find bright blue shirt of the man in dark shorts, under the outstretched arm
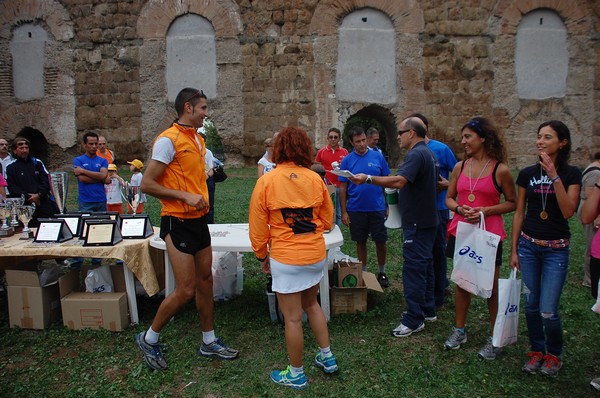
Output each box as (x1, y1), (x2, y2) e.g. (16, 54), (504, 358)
(339, 150), (390, 212)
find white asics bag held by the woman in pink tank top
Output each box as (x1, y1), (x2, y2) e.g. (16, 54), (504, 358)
(450, 213), (500, 298)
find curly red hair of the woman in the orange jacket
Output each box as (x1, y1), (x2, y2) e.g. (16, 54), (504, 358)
(272, 127), (314, 168)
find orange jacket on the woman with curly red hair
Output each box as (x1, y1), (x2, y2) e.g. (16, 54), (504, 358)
(249, 163), (333, 265)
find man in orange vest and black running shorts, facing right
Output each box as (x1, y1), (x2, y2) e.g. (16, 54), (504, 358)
(135, 88), (239, 370)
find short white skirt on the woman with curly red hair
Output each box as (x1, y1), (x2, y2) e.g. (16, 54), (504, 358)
(270, 257), (327, 294)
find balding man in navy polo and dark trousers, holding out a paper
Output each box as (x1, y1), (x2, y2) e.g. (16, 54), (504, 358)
(350, 117), (439, 337)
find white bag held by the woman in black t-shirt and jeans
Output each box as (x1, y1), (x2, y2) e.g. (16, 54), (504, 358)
(492, 268), (521, 347)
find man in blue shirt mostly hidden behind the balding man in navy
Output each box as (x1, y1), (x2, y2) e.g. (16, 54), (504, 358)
(409, 113), (457, 307)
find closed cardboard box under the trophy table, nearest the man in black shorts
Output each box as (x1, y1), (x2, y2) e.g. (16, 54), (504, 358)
(61, 292), (129, 332)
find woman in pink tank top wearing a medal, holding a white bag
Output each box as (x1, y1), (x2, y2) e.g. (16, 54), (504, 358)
(444, 117), (516, 360)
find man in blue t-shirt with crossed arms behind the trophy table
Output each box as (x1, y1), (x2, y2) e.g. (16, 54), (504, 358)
(73, 131), (108, 212)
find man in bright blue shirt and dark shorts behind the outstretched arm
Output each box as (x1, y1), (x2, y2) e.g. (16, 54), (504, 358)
(339, 126), (390, 287)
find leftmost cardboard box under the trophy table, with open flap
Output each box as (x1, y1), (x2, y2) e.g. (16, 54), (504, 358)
(6, 262), (79, 329)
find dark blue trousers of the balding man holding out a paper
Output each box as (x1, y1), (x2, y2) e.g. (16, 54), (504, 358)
(402, 226), (437, 329)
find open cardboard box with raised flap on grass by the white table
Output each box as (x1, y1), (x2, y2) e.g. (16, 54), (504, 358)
(330, 272), (383, 315)
